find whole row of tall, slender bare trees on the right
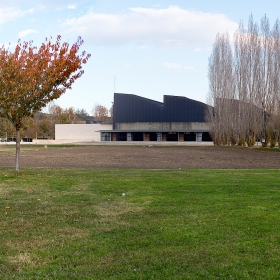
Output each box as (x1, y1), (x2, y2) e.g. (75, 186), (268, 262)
(206, 15), (280, 147)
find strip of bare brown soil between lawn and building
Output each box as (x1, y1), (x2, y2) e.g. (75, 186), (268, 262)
(0, 145), (280, 169)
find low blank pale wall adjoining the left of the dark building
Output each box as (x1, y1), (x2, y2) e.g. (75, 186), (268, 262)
(55, 124), (113, 142)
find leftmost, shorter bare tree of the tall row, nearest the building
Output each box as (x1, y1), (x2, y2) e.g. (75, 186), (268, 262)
(206, 34), (234, 145)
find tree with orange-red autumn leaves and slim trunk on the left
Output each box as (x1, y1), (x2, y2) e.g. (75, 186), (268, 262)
(0, 36), (90, 172)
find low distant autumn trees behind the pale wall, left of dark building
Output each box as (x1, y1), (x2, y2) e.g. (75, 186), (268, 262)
(0, 103), (113, 141)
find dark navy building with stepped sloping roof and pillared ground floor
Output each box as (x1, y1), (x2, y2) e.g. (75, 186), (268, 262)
(100, 93), (212, 142)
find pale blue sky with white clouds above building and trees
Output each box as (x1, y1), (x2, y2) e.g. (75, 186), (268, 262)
(0, 0), (280, 114)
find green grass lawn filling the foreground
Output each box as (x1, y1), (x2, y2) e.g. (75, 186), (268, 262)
(0, 168), (280, 279)
